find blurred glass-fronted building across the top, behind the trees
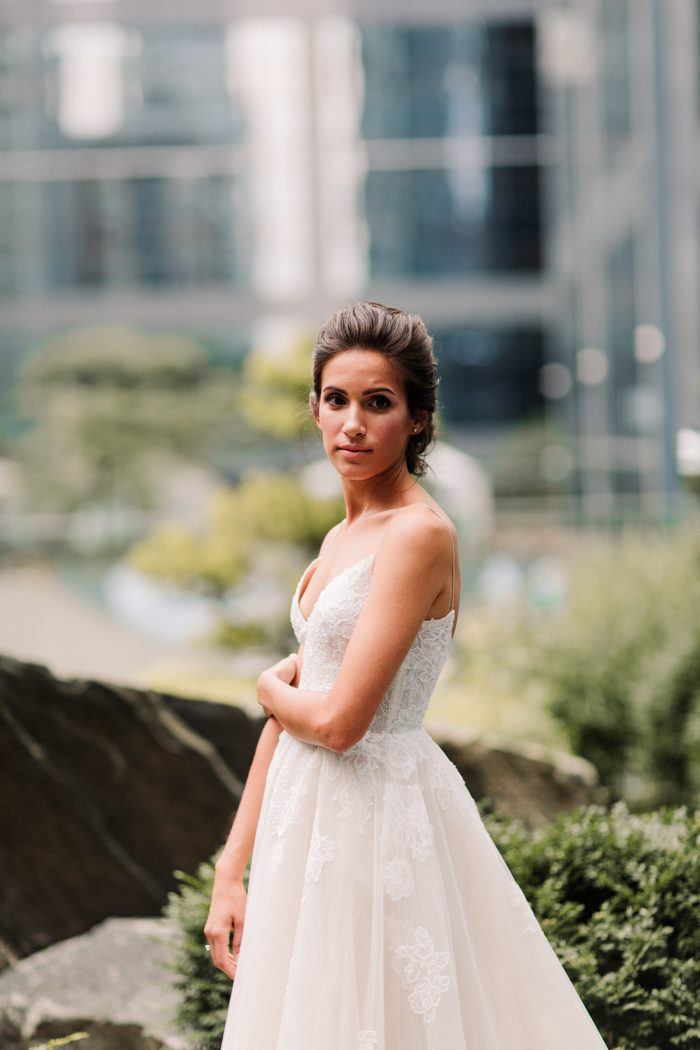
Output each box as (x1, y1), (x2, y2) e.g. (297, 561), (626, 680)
(0, 0), (699, 522)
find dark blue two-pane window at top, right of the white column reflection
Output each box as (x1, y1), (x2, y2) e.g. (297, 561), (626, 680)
(361, 22), (543, 279)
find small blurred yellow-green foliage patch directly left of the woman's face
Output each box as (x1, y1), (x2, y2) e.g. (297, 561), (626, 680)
(238, 333), (316, 441)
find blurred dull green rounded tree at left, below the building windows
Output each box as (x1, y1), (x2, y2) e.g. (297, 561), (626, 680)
(17, 324), (241, 510)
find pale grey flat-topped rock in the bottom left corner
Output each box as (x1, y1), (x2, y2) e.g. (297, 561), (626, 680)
(0, 919), (191, 1050)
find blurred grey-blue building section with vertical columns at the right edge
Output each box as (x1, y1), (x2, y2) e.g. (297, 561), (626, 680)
(539, 0), (700, 522)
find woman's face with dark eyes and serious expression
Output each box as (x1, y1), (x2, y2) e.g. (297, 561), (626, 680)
(316, 350), (422, 480)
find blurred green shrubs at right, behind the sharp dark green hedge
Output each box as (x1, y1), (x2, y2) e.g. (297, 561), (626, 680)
(455, 523), (700, 807)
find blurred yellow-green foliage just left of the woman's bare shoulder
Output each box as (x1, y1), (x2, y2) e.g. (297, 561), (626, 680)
(126, 470), (344, 595)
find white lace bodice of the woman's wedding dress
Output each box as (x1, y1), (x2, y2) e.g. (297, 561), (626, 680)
(291, 554), (454, 750)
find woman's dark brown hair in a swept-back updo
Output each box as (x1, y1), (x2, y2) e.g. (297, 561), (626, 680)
(309, 301), (440, 478)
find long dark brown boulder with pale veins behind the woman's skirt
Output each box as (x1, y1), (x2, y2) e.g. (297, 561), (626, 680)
(0, 657), (600, 969)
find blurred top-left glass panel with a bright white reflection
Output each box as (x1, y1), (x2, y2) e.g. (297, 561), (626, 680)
(0, 21), (246, 149)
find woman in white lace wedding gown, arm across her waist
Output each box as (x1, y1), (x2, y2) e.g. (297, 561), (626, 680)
(204, 302), (606, 1050)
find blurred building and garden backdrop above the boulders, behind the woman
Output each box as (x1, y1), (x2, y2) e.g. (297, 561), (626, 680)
(0, 0), (700, 805)
